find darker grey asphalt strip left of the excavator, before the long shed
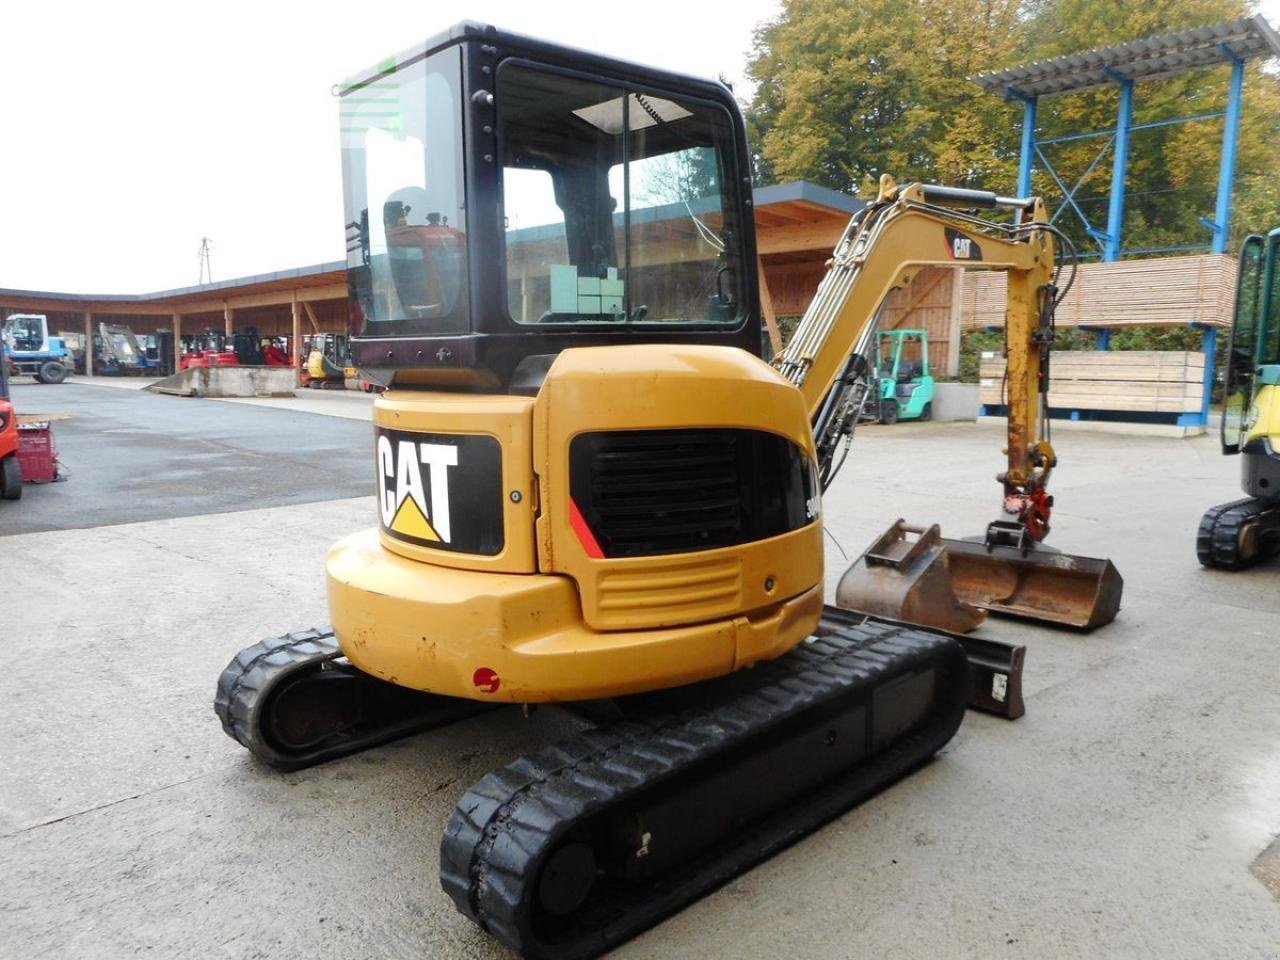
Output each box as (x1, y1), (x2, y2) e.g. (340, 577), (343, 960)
(0, 380), (372, 534)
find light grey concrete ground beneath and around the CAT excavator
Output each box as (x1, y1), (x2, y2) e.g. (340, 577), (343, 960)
(0, 407), (1280, 960)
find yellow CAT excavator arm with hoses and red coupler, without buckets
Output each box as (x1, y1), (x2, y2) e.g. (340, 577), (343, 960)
(773, 174), (1059, 548)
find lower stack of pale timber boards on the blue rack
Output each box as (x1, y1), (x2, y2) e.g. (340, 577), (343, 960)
(978, 349), (1204, 413)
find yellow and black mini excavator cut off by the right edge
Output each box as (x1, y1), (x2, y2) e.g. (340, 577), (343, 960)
(1196, 228), (1280, 570)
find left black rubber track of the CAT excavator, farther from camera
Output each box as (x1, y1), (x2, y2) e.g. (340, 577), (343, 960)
(214, 626), (489, 771)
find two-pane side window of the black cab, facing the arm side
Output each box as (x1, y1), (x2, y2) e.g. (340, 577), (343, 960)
(497, 63), (744, 325)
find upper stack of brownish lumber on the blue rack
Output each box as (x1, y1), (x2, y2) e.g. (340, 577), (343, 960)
(960, 253), (1236, 329)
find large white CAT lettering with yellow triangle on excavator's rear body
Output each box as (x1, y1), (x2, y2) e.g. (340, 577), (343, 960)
(378, 433), (458, 544)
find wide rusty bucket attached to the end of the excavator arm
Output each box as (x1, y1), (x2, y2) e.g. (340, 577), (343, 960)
(941, 538), (1124, 630)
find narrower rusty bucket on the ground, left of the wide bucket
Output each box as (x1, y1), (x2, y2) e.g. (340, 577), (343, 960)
(836, 520), (987, 634)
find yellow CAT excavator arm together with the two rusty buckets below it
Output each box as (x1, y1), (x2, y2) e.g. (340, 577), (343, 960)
(788, 177), (1123, 632)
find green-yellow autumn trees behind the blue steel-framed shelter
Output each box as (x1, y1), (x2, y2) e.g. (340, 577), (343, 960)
(748, 0), (1280, 252)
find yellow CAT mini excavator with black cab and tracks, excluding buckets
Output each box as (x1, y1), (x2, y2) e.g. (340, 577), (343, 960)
(215, 24), (1121, 957)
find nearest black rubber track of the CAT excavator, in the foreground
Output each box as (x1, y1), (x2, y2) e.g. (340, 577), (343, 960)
(440, 621), (969, 960)
